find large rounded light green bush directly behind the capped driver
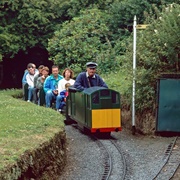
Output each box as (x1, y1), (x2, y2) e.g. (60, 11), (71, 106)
(48, 8), (119, 72)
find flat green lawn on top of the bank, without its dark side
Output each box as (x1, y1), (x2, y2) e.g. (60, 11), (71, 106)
(0, 90), (64, 174)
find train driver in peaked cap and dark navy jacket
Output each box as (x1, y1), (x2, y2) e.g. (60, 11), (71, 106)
(74, 62), (108, 91)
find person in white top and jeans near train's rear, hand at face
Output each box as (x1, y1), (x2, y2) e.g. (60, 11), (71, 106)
(26, 66), (38, 102)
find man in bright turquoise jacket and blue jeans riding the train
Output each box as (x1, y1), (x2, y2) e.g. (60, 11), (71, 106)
(44, 65), (63, 107)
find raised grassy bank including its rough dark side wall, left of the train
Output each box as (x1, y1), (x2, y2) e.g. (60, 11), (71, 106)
(0, 90), (66, 179)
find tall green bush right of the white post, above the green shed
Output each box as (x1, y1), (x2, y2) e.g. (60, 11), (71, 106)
(123, 4), (180, 111)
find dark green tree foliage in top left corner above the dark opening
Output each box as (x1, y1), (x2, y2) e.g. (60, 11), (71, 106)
(0, 0), (68, 60)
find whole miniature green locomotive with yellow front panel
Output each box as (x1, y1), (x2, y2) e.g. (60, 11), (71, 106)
(65, 86), (122, 134)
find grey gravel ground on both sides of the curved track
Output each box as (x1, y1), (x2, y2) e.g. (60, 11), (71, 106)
(59, 126), (180, 180)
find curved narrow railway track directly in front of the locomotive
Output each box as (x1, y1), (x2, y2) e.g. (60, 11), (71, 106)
(93, 136), (127, 180)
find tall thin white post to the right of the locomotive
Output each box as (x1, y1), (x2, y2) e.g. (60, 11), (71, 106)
(132, 16), (137, 134)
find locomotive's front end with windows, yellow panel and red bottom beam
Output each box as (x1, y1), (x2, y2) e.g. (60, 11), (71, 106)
(86, 88), (121, 133)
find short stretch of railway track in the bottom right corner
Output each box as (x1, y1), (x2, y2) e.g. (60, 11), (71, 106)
(153, 136), (180, 180)
